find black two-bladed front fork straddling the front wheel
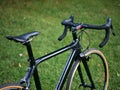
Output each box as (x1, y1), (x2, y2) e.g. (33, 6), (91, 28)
(77, 57), (95, 90)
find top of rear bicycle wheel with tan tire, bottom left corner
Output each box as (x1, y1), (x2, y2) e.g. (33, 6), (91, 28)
(0, 83), (25, 90)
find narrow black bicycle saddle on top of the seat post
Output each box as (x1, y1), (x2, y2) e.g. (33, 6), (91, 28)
(6, 31), (39, 44)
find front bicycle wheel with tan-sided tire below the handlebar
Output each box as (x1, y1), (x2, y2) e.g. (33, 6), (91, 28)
(66, 49), (109, 90)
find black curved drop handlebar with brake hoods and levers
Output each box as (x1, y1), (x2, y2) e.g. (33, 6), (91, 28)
(58, 16), (115, 47)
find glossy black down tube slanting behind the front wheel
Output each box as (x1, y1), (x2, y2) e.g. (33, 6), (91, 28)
(55, 49), (76, 90)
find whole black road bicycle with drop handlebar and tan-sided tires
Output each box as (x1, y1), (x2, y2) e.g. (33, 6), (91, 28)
(0, 16), (114, 90)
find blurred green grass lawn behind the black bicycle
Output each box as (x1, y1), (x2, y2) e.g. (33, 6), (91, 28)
(0, 0), (120, 90)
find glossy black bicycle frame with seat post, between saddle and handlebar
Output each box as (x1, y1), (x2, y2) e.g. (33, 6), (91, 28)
(20, 33), (93, 90)
